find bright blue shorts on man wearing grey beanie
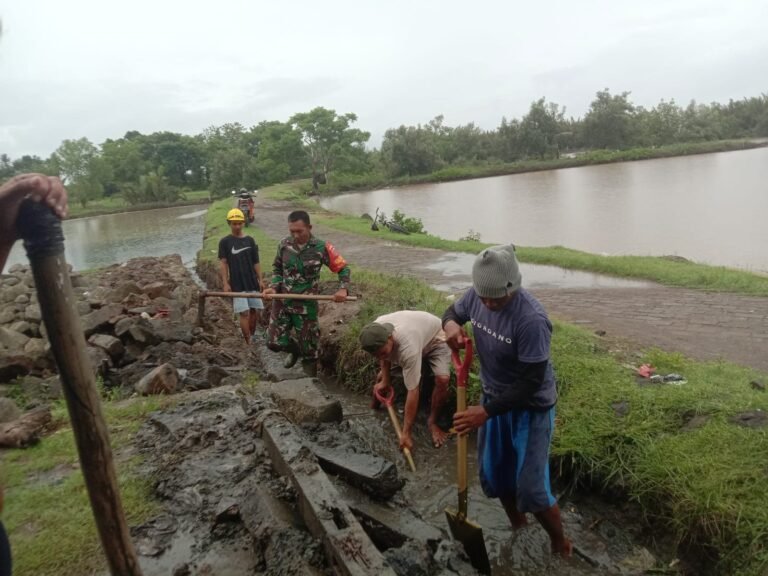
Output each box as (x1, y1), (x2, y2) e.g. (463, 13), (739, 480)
(477, 406), (557, 513)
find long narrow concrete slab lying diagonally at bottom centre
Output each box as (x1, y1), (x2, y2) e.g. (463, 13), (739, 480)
(261, 412), (395, 576)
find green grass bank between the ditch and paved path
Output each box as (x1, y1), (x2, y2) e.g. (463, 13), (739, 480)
(203, 197), (768, 576)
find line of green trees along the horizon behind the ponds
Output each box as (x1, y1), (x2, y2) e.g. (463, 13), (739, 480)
(0, 89), (768, 206)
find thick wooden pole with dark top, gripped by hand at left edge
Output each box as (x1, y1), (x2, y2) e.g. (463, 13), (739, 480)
(16, 201), (141, 576)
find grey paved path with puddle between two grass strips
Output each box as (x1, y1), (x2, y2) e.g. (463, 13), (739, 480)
(256, 203), (768, 372)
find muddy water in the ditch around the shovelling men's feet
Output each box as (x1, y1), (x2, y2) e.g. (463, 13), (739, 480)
(316, 380), (670, 576)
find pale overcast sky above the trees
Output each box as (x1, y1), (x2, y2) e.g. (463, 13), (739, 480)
(0, 0), (768, 158)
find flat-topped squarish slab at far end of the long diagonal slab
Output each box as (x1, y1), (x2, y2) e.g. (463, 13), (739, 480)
(263, 378), (343, 424)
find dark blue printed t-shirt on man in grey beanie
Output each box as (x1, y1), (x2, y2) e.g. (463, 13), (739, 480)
(454, 288), (557, 409)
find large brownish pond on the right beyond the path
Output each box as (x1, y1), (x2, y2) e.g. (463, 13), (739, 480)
(322, 148), (768, 271)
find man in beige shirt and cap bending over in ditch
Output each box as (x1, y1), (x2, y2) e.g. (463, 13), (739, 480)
(360, 310), (451, 450)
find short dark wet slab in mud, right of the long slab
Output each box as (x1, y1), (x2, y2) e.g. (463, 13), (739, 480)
(310, 444), (405, 500)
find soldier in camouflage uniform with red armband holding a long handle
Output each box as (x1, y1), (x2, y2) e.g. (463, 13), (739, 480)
(263, 210), (350, 375)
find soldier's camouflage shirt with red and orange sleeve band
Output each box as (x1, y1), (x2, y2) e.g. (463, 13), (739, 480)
(272, 236), (350, 314)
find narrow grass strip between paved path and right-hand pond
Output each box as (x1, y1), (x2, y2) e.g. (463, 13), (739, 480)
(261, 181), (768, 296)
